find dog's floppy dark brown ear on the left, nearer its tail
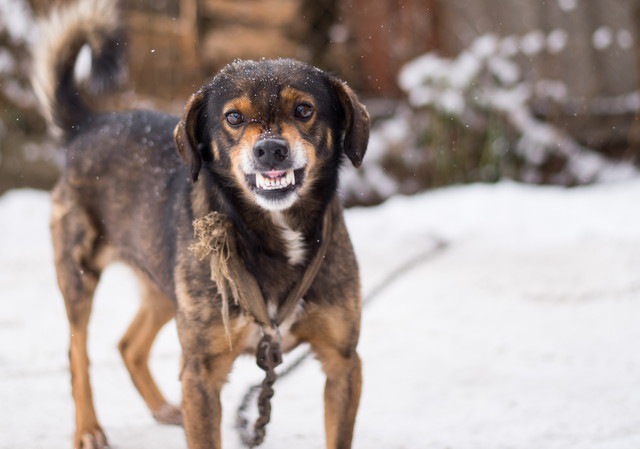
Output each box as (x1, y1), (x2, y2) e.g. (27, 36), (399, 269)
(173, 92), (205, 182)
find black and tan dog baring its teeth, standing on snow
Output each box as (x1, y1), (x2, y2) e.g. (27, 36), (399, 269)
(34, 0), (369, 449)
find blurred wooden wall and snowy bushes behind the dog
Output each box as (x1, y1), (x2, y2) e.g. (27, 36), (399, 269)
(0, 0), (640, 204)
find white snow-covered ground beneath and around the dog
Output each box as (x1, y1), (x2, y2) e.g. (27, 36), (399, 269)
(0, 181), (640, 449)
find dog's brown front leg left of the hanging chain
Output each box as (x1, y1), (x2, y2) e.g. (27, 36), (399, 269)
(182, 354), (233, 449)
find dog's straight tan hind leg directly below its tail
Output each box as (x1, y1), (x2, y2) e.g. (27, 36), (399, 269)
(51, 190), (107, 449)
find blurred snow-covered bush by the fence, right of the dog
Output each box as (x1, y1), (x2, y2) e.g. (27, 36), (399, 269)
(343, 29), (640, 205)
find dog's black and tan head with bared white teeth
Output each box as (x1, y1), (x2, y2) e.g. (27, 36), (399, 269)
(174, 59), (369, 210)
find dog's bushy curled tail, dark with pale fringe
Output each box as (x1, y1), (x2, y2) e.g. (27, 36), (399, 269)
(32, 0), (126, 138)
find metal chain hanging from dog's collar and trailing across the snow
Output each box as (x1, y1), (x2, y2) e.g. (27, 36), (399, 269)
(236, 238), (448, 448)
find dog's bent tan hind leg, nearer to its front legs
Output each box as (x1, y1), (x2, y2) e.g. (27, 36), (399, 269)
(118, 274), (182, 425)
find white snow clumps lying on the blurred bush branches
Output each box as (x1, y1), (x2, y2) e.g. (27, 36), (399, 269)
(392, 32), (638, 191)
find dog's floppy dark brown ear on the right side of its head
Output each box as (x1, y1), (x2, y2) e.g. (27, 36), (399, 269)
(331, 77), (369, 167)
